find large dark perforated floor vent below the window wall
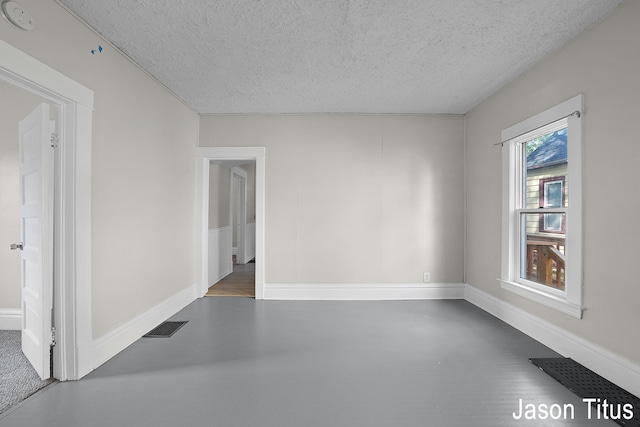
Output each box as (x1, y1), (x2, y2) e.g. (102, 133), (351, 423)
(529, 358), (640, 427)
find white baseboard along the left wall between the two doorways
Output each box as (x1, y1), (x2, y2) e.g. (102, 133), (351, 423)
(93, 284), (197, 369)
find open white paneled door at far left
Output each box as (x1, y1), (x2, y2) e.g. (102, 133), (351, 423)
(19, 104), (53, 379)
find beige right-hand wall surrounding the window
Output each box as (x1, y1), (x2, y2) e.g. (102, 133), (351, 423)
(466, 1), (640, 363)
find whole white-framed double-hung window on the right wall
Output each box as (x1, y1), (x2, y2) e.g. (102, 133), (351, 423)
(500, 95), (582, 318)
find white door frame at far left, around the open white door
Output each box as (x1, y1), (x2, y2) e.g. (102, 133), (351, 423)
(0, 40), (93, 381)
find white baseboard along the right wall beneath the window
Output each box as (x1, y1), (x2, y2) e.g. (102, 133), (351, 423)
(464, 285), (640, 396)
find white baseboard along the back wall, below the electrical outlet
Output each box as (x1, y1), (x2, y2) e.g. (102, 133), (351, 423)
(264, 283), (465, 301)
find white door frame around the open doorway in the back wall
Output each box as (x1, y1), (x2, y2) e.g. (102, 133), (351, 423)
(196, 147), (266, 299)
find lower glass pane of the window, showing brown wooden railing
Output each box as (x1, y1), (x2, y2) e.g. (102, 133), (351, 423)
(520, 213), (566, 291)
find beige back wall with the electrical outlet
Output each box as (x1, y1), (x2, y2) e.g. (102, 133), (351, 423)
(200, 115), (464, 283)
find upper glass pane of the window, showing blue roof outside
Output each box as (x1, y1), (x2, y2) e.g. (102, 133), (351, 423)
(522, 128), (569, 209)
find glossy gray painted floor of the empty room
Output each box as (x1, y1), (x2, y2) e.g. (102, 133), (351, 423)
(0, 297), (616, 427)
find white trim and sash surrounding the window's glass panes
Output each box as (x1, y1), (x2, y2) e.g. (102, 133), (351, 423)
(498, 95), (584, 319)
